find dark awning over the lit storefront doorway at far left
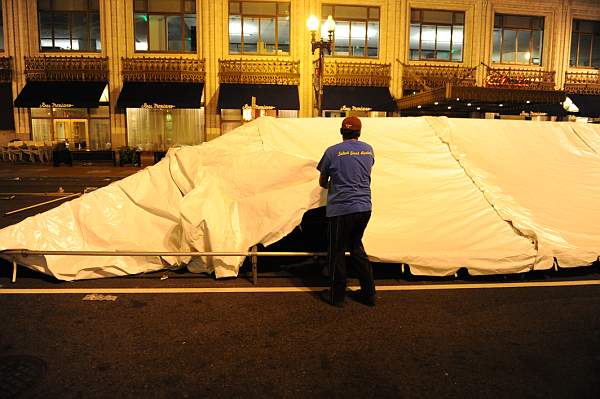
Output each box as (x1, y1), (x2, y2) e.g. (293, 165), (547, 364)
(15, 81), (107, 108)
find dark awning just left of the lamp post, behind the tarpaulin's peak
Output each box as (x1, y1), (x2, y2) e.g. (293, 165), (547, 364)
(217, 83), (300, 110)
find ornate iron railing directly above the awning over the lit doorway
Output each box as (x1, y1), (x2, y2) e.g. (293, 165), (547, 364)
(24, 56), (108, 82)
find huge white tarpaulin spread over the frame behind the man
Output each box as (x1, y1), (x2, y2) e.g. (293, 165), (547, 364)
(0, 117), (600, 280)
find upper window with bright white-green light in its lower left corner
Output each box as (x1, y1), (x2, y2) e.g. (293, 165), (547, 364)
(134, 0), (196, 53)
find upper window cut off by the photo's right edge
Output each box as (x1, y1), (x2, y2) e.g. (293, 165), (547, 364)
(569, 19), (600, 68)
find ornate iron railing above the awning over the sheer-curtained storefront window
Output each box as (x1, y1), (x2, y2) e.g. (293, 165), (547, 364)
(121, 57), (206, 83)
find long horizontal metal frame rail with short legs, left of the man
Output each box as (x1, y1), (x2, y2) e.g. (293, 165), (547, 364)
(0, 245), (338, 285)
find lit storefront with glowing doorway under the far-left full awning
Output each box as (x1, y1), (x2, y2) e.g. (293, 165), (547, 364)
(31, 106), (112, 150)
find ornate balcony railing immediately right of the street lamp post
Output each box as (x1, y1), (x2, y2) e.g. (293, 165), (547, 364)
(322, 61), (391, 87)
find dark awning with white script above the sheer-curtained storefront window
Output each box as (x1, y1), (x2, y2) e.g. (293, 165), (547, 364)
(117, 82), (204, 108)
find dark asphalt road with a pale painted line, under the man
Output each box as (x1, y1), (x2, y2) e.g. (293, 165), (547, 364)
(0, 176), (600, 398)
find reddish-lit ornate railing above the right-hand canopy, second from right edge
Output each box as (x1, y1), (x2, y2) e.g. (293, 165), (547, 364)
(484, 67), (556, 90)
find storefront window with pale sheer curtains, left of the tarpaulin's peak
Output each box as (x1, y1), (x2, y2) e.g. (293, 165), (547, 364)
(127, 108), (204, 151)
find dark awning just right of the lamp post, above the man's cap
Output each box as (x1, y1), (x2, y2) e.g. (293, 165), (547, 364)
(321, 86), (396, 112)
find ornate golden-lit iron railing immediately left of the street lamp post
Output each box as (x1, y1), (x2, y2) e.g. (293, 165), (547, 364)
(219, 59), (300, 85)
